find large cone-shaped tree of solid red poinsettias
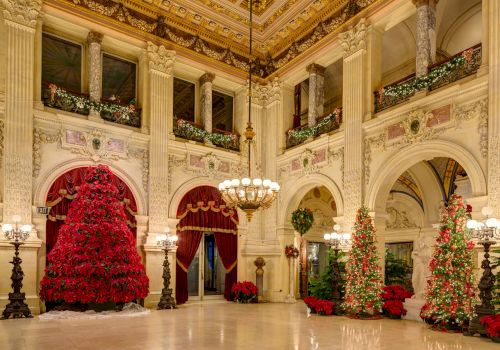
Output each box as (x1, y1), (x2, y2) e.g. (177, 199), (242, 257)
(40, 165), (149, 304)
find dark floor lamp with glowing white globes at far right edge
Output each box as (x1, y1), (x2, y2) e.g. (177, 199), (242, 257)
(464, 207), (500, 335)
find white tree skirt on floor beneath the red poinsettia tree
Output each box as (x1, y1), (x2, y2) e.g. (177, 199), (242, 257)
(38, 303), (150, 320)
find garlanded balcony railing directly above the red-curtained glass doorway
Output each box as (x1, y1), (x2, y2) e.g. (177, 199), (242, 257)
(174, 119), (240, 151)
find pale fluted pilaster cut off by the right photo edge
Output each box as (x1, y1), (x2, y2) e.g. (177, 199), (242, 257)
(488, 1), (500, 217)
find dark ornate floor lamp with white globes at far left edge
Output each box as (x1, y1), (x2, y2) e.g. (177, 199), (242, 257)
(2, 215), (33, 320)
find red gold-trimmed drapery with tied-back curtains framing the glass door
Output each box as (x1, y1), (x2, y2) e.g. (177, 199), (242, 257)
(175, 186), (238, 304)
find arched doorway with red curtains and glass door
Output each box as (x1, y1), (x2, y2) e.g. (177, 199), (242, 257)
(175, 186), (238, 304)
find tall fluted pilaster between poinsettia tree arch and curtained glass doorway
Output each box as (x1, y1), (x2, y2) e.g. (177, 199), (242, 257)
(144, 42), (175, 306)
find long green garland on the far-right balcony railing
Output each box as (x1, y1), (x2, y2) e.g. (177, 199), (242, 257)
(379, 48), (474, 99)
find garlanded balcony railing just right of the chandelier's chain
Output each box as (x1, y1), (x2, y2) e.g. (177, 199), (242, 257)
(286, 108), (342, 149)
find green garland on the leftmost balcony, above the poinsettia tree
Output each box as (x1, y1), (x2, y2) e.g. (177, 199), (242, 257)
(49, 84), (136, 120)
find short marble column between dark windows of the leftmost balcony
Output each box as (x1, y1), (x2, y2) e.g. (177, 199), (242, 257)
(87, 32), (102, 120)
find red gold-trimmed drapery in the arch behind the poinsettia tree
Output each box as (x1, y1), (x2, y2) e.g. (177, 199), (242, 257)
(46, 167), (137, 255)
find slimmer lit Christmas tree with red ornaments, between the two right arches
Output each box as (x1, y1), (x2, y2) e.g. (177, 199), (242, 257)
(344, 207), (383, 317)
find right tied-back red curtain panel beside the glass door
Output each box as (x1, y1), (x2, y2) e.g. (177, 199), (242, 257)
(214, 232), (238, 301)
